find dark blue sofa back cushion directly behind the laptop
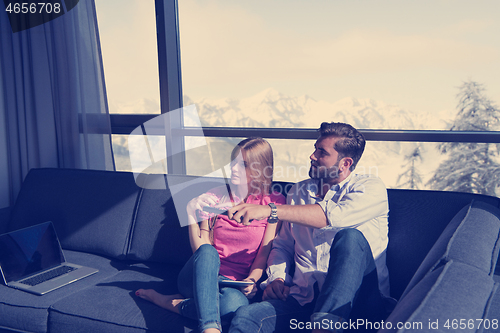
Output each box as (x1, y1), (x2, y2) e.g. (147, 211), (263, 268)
(9, 169), (141, 258)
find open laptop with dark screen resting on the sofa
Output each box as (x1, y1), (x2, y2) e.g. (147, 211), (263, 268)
(0, 221), (98, 295)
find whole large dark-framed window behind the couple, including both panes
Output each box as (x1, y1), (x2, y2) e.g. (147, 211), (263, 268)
(96, 0), (500, 195)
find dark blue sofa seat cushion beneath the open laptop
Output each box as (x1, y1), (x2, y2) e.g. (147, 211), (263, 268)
(0, 251), (124, 332)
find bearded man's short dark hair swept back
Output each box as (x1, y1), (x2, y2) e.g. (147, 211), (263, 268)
(319, 122), (365, 171)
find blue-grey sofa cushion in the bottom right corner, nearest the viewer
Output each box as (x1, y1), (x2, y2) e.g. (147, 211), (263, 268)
(379, 260), (496, 332)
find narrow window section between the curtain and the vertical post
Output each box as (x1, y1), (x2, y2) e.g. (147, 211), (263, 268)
(95, 0), (160, 171)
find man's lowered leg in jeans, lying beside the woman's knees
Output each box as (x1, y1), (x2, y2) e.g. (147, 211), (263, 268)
(229, 296), (312, 333)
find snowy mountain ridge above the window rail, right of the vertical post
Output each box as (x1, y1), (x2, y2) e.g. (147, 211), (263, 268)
(184, 88), (453, 129)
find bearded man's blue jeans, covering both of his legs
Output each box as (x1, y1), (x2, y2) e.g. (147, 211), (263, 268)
(229, 229), (387, 333)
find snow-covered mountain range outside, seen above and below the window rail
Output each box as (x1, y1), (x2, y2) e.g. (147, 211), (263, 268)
(110, 88), (455, 187)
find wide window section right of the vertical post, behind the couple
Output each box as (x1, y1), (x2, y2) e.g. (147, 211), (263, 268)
(179, 0), (500, 194)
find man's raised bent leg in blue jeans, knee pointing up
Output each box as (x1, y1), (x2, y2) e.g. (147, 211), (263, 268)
(311, 229), (385, 331)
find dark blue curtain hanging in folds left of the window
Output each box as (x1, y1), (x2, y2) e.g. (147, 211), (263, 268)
(0, 0), (115, 208)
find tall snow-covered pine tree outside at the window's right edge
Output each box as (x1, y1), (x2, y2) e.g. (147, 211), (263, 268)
(428, 81), (500, 195)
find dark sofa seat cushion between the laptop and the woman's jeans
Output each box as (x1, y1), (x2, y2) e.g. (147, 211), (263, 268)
(49, 263), (193, 333)
